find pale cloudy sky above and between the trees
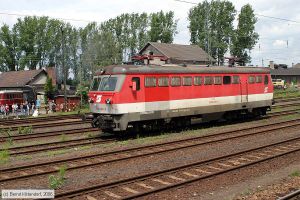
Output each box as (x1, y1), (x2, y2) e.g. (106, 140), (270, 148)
(0, 0), (300, 66)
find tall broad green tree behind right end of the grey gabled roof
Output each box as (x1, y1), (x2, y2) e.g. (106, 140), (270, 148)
(188, 0), (236, 64)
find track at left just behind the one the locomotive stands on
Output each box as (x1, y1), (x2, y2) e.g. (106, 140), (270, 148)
(0, 128), (99, 142)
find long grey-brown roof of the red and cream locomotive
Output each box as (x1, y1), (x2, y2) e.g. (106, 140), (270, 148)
(96, 65), (270, 75)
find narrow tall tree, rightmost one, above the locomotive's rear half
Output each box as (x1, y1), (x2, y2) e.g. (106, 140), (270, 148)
(231, 4), (259, 63)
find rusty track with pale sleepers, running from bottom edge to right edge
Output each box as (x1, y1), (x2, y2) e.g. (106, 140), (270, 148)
(55, 134), (300, 199)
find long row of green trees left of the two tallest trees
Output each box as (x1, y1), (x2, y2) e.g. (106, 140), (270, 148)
(0, 11), (177, 81)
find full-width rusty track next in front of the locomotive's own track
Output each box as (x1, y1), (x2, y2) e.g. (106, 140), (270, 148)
(0, 119), (300, 183)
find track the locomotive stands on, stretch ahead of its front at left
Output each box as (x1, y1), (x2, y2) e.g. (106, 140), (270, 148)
(0, 130), (111, 156)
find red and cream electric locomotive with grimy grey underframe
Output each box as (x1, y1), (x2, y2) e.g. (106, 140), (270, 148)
(89, 65), (273, 131)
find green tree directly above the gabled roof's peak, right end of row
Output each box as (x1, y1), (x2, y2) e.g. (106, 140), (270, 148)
(149, 11), (178, 43)
